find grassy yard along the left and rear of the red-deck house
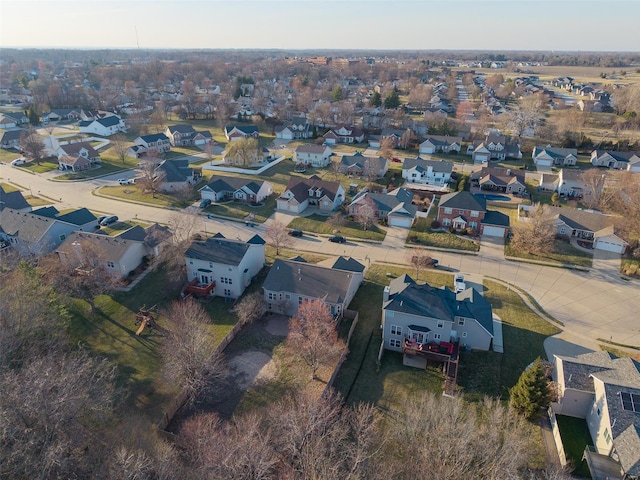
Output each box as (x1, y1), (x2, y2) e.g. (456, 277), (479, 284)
(334, 264), (451, 410)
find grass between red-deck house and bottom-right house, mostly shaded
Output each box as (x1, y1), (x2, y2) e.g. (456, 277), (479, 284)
(458, 280), (560, 400)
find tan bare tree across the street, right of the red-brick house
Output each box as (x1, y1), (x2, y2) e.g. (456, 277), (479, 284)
(510, 203), (555, 254)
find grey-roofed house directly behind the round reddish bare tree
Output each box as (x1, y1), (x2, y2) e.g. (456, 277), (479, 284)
(262, 257), (364, 317)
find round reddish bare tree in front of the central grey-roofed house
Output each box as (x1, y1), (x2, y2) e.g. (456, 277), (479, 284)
(287, 299), (345, 380)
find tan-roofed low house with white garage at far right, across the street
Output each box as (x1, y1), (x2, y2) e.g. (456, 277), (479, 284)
(518, 205), (628, 254)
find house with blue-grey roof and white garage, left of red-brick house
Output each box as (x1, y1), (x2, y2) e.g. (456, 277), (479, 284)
(349, 188), (418, 228)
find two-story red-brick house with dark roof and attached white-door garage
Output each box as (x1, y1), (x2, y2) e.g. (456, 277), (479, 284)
(438, 191), (509, 238)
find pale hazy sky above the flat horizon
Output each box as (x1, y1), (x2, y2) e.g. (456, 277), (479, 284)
(0, 0), (640, 52)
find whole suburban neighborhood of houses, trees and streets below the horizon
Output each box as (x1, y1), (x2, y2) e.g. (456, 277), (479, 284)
(0, 39), (640, 480)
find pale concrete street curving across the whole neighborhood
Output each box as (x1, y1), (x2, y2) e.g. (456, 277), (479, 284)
(5, 164), (640, 348)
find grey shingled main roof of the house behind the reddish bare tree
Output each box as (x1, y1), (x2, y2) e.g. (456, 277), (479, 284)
(262, 258), (354, 304)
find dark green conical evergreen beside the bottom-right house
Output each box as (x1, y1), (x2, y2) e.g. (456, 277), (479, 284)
(509, 357), (549, 419)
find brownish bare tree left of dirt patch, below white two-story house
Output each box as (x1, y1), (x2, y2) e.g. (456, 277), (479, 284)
(160, 298), (223, 401)
